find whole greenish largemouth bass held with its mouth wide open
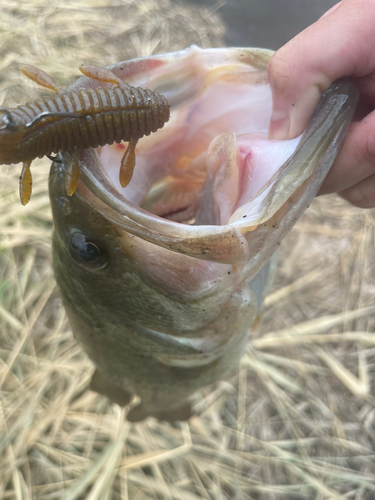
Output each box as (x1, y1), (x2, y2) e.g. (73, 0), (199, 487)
(50, 47), (358, 421)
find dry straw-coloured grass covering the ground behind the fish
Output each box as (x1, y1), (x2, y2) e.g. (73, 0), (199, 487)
(0, 0), (375, 500)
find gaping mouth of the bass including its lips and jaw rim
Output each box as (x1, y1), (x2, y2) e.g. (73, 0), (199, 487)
(73, 47), (356, 263)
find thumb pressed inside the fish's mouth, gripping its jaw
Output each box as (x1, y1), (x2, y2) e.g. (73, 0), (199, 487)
(268, 0), (375, 139)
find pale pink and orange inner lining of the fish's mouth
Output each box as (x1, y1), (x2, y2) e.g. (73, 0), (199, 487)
(97, 59), (298, 225)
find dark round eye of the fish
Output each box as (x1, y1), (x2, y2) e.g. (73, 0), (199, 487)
(69, 233), (108, 269)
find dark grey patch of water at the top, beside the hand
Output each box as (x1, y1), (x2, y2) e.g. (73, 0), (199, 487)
(185, 0), (337, 50)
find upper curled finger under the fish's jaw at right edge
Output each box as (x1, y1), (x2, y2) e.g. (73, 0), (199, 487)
(319, 112), (375, 194)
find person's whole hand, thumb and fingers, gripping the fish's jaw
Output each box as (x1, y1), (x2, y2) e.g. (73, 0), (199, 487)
(268, 0), (375, 208)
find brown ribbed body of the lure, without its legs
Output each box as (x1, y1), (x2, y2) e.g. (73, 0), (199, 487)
(12, 87), (169, 163)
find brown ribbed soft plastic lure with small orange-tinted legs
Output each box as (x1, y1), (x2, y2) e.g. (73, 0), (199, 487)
(0, 64), (169, 205)
